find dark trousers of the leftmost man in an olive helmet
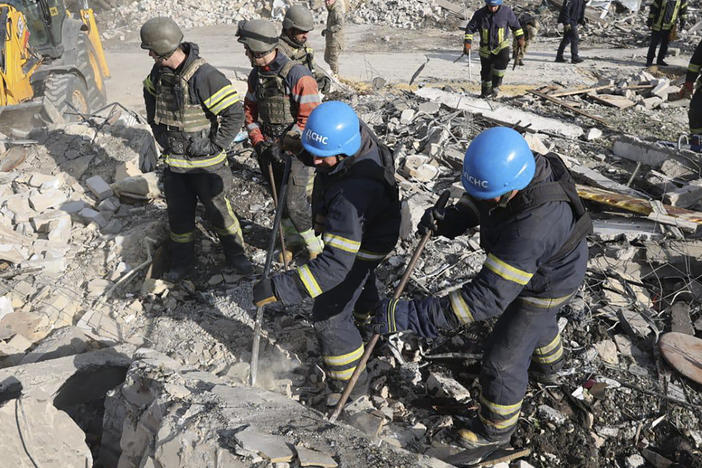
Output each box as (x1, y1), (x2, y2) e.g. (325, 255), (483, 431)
(163, 164), (244, 264)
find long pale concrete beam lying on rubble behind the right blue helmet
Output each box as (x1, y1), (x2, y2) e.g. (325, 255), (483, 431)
(414, 87), (583, 138)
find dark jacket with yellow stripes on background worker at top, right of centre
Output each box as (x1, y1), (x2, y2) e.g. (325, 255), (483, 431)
(464, 5), (524, 57)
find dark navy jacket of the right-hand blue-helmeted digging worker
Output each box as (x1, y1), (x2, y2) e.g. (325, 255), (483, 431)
(398, 155), (588, 336)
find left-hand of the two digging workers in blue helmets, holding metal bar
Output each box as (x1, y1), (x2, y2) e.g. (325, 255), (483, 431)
(253, 101), (400, 402)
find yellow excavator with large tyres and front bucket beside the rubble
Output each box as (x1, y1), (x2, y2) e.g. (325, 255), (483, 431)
(0, 0), (110, 135)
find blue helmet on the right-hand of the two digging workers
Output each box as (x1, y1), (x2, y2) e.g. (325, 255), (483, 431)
(461, 127), (536, 200)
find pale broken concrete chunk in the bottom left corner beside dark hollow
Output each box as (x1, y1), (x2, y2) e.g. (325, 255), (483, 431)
(0, 396), (93, 468)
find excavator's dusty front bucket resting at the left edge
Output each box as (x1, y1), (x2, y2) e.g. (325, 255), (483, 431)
(0, 98), (64, 136)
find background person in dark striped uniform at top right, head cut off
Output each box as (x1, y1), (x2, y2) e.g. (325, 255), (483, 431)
(646, 0), (687, 67)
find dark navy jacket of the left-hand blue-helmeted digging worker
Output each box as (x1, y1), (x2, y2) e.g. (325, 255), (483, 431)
(272, 123), (400, 304)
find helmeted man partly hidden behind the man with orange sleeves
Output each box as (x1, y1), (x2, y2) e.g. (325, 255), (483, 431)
(278, 5), (330, 92)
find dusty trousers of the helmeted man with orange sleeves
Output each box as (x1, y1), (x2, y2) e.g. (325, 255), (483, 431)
(256, 156), (314, 232)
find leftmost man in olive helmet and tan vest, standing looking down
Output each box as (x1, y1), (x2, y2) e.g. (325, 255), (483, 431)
(141, 17), (253, 282)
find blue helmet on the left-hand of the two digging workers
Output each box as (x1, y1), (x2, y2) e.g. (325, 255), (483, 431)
(302, 101), (361, 158)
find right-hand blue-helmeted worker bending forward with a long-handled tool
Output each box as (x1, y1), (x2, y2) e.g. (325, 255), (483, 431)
(372, 127), (592, 463)
